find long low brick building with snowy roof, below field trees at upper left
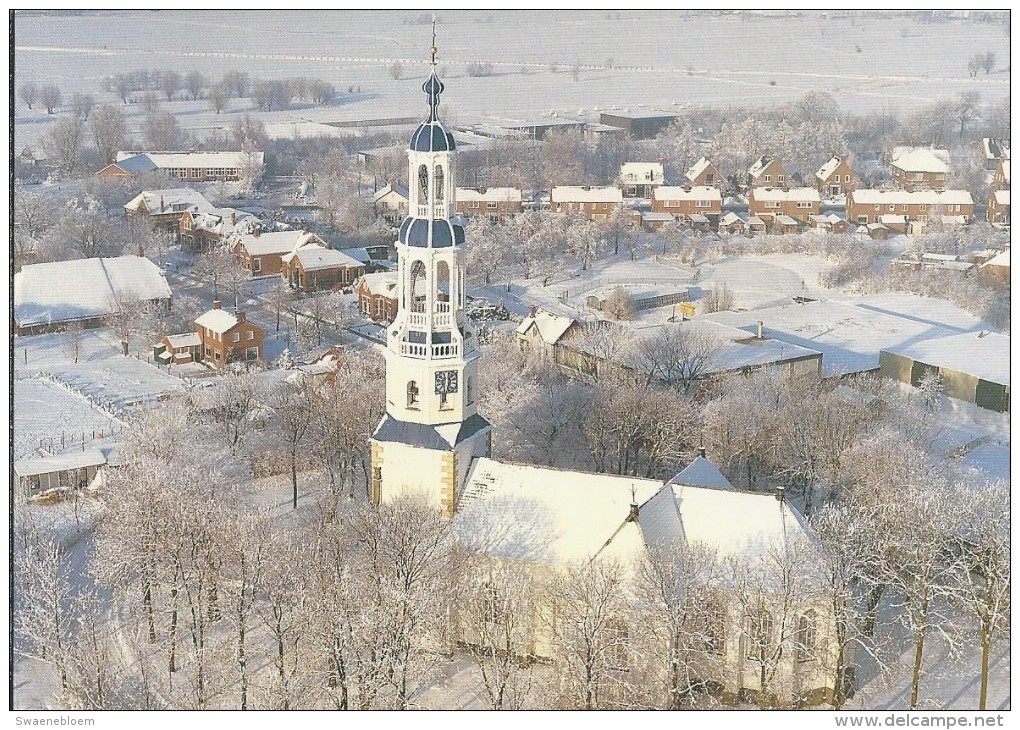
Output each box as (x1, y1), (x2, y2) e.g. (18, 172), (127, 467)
(96, 150), (265, 183)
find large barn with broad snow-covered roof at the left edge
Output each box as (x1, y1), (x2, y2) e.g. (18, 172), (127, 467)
(14, 256), (171, 334)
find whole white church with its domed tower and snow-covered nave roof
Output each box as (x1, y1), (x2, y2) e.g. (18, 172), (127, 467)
(369, 38), (834, 706)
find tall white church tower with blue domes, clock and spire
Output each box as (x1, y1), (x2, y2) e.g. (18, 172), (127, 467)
(369, 28), (492, 516)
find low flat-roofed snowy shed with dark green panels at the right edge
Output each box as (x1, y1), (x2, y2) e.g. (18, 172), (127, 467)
(879, 331), (1010, 413)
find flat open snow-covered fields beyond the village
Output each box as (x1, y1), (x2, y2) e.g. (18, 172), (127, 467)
(13, 10), (1010, 148)
